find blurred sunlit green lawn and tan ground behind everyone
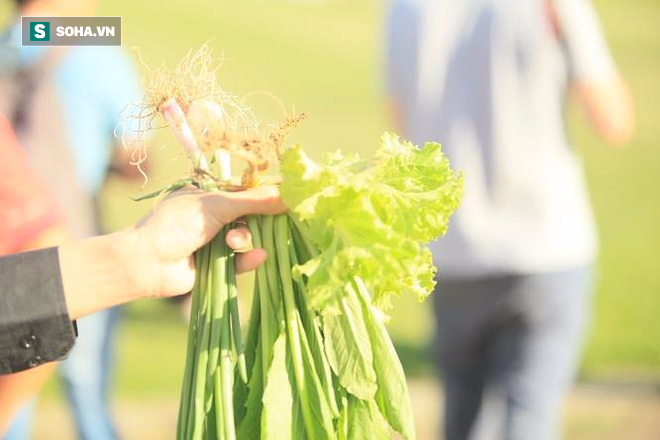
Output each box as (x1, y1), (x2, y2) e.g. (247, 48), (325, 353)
(0, 0), (660, 440)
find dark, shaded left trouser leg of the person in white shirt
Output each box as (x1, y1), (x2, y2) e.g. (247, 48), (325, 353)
(434, 277), (512, 440)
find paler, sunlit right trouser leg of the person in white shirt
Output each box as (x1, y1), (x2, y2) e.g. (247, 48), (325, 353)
(475, 268), (592, 440)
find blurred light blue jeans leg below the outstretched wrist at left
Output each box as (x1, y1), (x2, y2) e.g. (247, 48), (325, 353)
(60, 308), (119, 440)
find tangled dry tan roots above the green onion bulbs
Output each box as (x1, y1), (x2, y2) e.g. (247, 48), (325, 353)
(121, 44), (305, 189)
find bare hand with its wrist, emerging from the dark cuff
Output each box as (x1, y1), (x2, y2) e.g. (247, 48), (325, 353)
(59, 187), (285, 319)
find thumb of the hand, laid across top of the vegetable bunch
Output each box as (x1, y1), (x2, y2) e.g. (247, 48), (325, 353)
(204, 186), (286, 223)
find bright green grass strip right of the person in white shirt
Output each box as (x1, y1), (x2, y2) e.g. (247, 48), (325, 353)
(572, 0), (660, 378)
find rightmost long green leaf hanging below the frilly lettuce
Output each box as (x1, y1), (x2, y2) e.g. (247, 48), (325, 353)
(349, 279), (416, 440)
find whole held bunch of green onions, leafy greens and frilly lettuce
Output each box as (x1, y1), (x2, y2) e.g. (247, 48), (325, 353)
(126, 48), (462, 440)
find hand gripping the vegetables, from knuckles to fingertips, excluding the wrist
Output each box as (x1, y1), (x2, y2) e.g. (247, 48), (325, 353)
(126, 187), (286, 297)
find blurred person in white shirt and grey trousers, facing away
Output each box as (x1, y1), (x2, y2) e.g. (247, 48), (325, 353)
(386, 0), (634, 440)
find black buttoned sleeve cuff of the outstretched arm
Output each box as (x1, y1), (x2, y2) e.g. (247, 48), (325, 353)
(0, 248), (76, 374)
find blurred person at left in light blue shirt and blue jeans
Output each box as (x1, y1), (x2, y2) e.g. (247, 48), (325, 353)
(3, 0), (146, 440)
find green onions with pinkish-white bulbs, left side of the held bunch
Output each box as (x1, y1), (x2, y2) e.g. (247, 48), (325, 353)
(160, 99), (248, 440)
